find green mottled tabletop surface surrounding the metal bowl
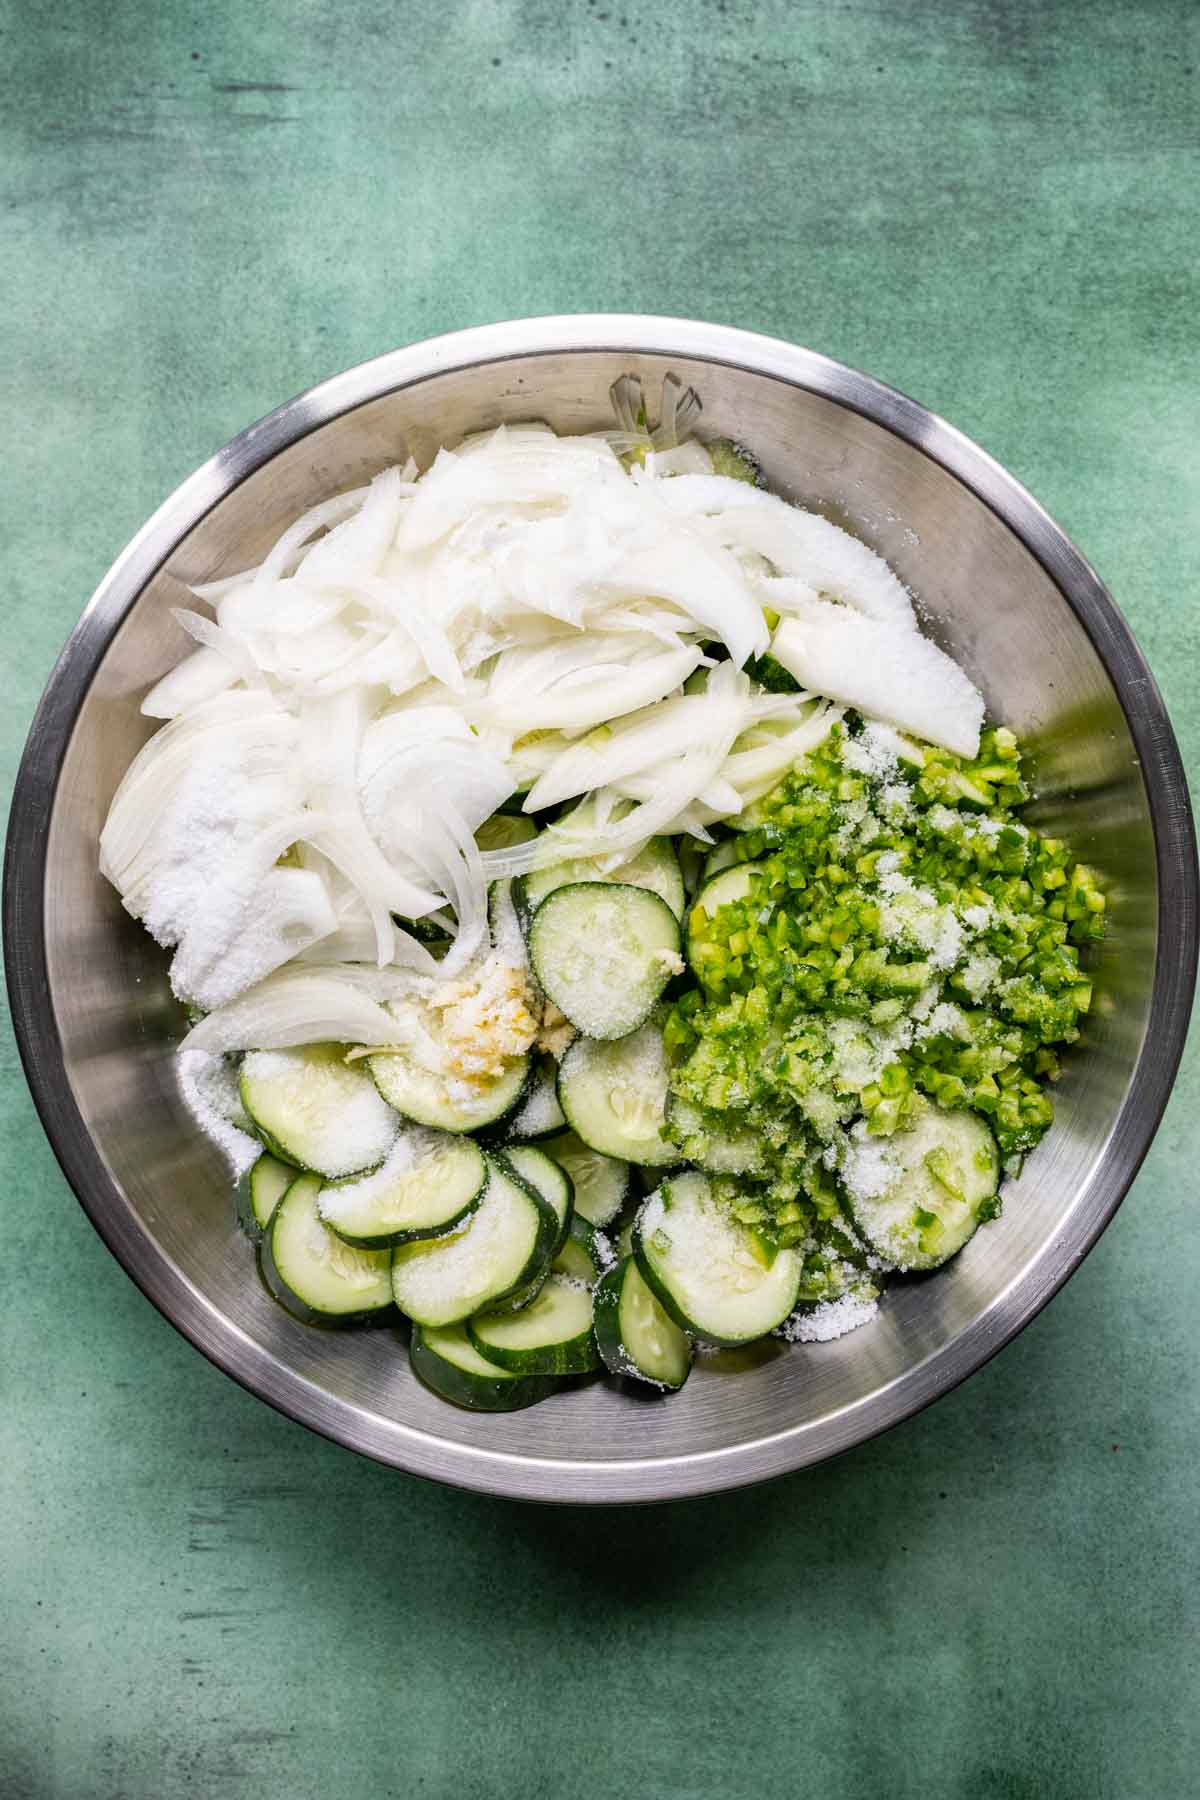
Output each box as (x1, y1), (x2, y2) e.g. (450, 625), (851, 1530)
(0, 0), (1200, 1800)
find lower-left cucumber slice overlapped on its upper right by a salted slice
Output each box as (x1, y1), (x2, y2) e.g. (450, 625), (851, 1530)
(259, 1175), (392, 1327)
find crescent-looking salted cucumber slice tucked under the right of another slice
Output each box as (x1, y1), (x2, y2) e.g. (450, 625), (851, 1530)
(392, 1157), (558, 1327)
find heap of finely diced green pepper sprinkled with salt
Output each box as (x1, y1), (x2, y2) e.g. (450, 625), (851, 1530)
(666, 720), (1105, 1294)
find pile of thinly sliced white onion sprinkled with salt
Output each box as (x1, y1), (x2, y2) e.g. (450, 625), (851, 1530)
(101, 383), (982, 1051)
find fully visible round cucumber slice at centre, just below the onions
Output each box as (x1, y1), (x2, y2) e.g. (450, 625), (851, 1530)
(529, 882), (684, 1039)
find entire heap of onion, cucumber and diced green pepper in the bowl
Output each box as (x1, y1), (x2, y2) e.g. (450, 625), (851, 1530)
(101, 378), (1103, 1409)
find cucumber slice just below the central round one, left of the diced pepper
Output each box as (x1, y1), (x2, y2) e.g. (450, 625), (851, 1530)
(558, 1017), (678, 1166)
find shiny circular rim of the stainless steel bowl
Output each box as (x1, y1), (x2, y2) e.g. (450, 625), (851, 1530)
(4, 313), (1200, 1503)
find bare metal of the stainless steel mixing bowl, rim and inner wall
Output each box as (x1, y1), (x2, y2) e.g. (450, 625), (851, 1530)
(4, 317), (1196, 1501)
